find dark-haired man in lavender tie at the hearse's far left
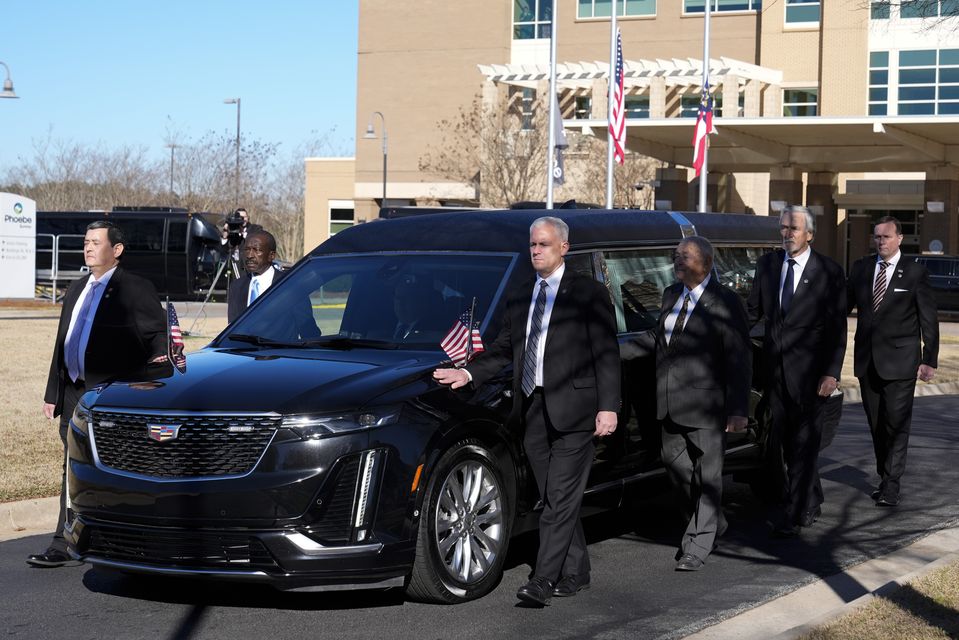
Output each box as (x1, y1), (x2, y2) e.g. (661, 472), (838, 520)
(27, 221), (167, 567)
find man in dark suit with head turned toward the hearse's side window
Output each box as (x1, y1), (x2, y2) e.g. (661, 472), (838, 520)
(624, 236), (752, 571)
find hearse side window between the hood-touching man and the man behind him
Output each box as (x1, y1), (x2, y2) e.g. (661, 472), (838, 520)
(603, 249), (676, 333)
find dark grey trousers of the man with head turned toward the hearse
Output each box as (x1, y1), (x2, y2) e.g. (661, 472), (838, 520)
(662, 417), (726, 560)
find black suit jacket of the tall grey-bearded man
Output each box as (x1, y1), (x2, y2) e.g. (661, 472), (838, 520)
(747, 249), (846, 401)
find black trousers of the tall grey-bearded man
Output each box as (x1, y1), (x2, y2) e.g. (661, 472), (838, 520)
(769, 374), (826, 525)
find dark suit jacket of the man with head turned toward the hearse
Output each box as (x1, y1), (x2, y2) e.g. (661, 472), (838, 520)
(656, 278), (752, 429)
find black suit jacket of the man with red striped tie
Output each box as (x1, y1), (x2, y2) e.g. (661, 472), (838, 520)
(847, 255), (939, 380)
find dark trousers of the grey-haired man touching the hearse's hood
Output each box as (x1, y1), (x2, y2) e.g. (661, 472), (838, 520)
(523, 390), (595, 581)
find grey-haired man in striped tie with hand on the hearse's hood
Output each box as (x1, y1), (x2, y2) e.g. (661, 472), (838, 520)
(433, 217), (620, 606)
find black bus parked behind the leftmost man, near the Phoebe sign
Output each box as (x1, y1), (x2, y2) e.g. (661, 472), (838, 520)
(36, 207), (226, 299)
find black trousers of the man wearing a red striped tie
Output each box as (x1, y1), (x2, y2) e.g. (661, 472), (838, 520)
(859, 362), (916, 498)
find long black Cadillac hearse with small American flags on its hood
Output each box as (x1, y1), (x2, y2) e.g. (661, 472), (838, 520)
(67, 210), (782, 602)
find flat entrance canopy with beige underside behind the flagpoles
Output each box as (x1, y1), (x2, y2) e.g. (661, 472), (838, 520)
(563, 116), (959, 173)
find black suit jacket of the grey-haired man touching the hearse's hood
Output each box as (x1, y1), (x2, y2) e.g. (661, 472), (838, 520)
(466, 268), (621, 431)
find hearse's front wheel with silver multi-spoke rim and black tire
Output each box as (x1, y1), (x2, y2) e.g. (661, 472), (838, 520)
(406, 440), (513, 604)
